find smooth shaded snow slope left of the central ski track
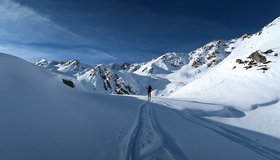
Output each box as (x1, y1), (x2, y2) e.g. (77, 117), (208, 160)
(0, 54), (143, 160)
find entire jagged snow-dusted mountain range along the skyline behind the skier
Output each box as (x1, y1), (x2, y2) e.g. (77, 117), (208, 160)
(35, 18), (279, 96)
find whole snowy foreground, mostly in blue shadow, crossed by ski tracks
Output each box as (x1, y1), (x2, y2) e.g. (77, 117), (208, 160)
(0, 54), (280, 160)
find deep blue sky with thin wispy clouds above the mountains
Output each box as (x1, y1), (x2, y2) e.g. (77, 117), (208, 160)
(0, 0), (280, 64)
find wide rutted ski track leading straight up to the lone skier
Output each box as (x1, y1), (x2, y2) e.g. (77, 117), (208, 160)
(124, 101), (188, 160)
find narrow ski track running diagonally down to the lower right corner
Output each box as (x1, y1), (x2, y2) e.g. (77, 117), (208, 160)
(156, 99), (280, 160)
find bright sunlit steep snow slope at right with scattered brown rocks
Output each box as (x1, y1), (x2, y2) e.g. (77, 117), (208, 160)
(171, 18), (280, 110)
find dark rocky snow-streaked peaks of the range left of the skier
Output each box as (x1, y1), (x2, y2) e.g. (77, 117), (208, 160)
(35, 59), (135, 94)
